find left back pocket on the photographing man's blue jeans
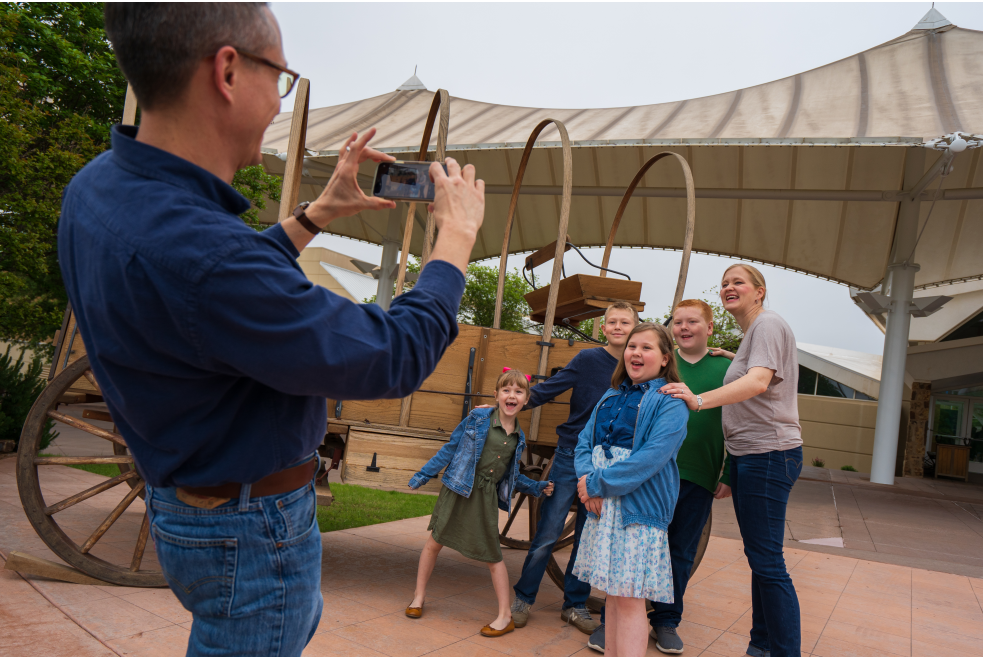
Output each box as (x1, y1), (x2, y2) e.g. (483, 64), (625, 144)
(153, 524), (239, 617)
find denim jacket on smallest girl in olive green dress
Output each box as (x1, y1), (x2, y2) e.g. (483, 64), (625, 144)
(410, 409), (549, 513)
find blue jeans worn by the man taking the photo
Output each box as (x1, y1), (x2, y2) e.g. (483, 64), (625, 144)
(147, 458), (324, 656)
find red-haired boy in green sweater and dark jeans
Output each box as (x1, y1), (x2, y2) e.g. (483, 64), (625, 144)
(649, 299), (734, 654)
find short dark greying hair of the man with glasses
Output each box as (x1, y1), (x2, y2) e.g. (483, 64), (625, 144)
(106, 2), (279, 110)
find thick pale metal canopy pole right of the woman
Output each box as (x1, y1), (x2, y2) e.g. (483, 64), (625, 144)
(870, 147), (926, 484)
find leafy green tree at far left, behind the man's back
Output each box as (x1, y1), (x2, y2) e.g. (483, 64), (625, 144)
(0, 2), (126, 347)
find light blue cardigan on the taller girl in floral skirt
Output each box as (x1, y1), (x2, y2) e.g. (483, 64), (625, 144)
(575, 378), (689, 530)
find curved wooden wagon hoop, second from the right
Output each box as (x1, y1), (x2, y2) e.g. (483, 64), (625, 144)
(492, 119), (573, 443)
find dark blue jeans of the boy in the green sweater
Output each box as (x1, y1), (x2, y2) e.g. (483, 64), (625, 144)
(649, 480), (713, 628)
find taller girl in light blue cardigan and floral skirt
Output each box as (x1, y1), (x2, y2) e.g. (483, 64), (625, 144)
(573, 322), (689, 656)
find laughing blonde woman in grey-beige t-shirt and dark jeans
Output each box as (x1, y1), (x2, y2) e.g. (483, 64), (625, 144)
(662, 263), (802, 656)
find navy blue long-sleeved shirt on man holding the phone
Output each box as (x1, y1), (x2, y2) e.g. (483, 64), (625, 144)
(58, 127), (464, 486)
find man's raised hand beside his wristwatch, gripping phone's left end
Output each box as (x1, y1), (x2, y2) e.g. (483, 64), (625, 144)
(306, 128), (396, 228)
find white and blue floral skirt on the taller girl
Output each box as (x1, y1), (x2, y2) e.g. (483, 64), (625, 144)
(573, 446), (673, 603)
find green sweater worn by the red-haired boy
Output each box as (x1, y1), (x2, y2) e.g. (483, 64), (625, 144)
(676, 349), (730, 492)
